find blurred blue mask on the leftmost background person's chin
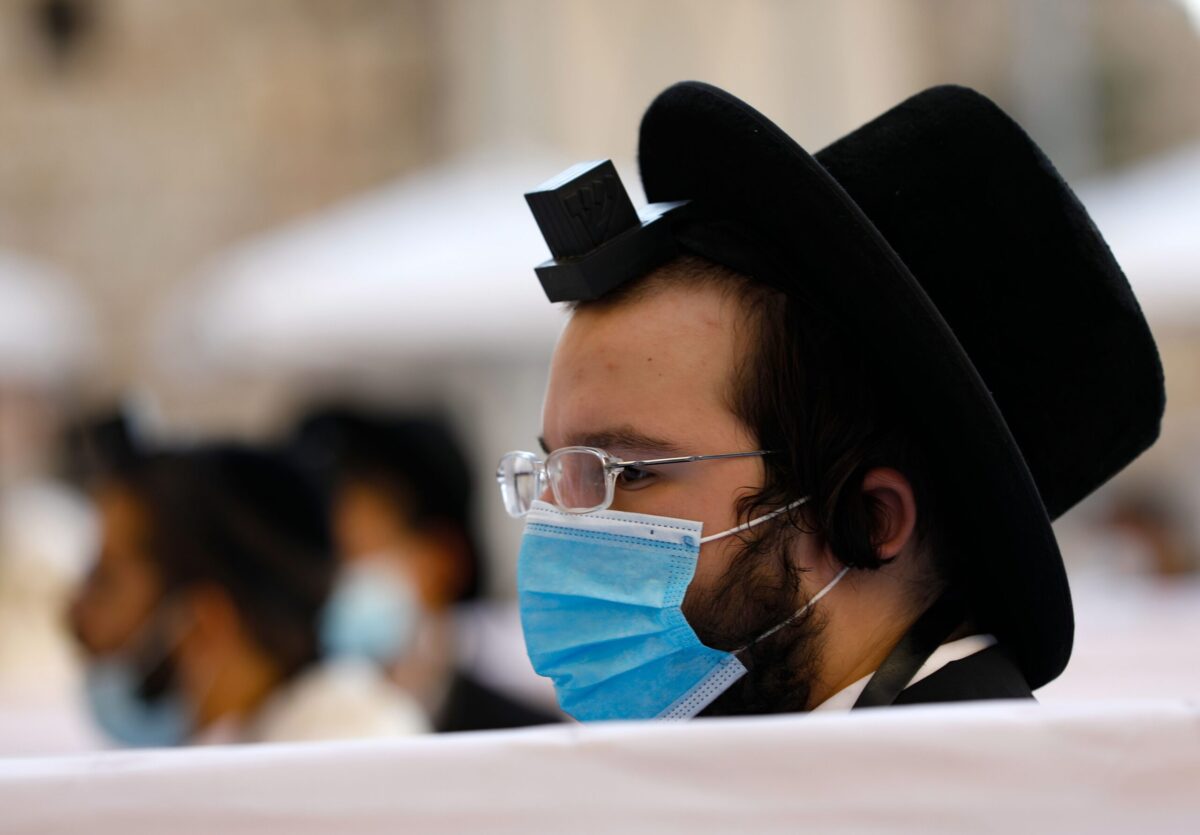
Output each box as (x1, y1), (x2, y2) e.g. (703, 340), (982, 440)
(84, 607), (196, 747)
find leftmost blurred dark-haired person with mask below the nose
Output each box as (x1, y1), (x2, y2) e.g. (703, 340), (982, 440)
(70, 431), (427, 746)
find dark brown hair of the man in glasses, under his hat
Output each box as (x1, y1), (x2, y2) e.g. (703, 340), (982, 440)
(577, 254), (944, 579)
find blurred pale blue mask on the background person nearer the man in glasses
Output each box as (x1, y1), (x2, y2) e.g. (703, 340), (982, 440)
(320, 557), (420, 663)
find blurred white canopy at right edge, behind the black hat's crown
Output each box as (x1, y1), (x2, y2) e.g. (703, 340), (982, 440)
(1079, 145), (1200, 325)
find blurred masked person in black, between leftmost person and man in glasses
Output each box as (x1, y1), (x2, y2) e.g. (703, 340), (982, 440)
(293, 407), (557, 732)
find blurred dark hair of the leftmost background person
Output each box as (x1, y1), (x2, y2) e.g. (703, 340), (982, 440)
(120, 445), (335, 677)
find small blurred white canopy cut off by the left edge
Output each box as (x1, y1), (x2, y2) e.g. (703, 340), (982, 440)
(0, 252), (95, 383)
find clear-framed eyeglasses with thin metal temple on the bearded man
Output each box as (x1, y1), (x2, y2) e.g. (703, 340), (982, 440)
(496, 446), (770, 518)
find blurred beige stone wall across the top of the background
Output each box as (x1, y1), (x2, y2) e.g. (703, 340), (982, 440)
(0, 0), (1200, 405)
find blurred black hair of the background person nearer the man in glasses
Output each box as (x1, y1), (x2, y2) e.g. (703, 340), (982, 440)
(293, 406), (486, 602)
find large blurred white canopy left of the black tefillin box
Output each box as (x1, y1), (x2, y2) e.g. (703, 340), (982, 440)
(155, 157), (585, 372)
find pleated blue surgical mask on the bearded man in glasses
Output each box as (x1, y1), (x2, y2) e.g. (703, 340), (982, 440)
(517, 499), (846, 721)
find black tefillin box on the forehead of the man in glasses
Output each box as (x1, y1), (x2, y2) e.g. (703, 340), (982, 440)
(526, 160), (688, 301)
